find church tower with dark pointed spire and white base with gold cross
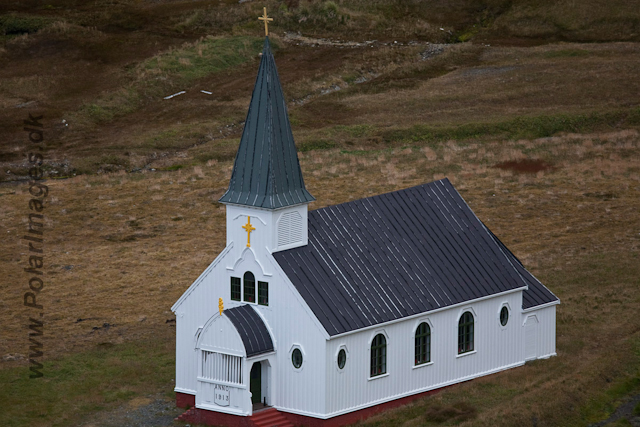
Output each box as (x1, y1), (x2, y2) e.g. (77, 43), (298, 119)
(220, 36), (315, 252)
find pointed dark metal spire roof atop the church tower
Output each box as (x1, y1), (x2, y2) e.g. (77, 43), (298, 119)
(220, 37), (315, 209)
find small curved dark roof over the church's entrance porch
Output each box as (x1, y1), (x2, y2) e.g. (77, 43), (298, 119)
(223, 304), (273, 357)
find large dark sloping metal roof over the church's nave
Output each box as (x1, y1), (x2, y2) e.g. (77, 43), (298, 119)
(273, 179), (556, 336)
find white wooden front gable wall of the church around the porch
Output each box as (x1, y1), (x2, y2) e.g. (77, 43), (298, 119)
(173, 205), (328, 416)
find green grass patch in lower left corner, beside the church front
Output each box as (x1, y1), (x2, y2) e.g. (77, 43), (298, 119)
(0, 337), (175, 427)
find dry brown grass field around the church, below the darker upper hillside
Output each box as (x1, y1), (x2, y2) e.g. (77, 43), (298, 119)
(0, 131), (640, 425)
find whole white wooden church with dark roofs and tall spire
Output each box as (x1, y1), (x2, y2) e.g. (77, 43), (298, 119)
(172, 33), (560, 426)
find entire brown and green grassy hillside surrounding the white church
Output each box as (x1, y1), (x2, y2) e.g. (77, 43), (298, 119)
(0, 0), (640, 426)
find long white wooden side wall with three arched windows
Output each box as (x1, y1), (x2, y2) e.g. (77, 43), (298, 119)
(326, 291), (523, 417)
